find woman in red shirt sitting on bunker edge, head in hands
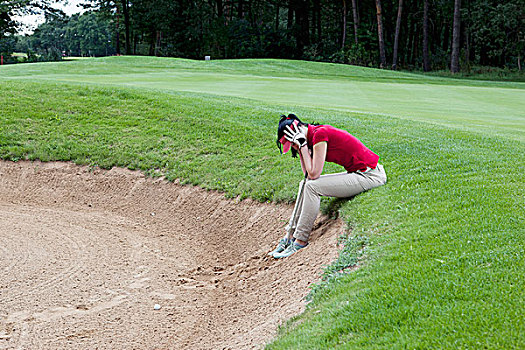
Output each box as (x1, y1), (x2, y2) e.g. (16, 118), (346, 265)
(270, 114), (386, 258)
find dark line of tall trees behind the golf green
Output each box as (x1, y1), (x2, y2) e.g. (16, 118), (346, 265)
(0, 0), (525, 72)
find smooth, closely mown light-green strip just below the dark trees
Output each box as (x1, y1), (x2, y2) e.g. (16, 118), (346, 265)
(0, 57), (525, 140)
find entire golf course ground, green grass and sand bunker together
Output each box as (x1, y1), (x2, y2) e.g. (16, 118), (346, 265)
(0, 56), (525, 349)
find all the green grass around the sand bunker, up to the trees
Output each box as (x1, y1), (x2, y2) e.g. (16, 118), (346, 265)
(0, 57), (525, 349)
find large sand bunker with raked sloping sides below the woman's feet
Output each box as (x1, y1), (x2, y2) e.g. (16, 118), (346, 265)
(0, 162), (343, 349)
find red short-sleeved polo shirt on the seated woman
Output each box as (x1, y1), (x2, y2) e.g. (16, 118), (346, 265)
(307, 125), (379, 172)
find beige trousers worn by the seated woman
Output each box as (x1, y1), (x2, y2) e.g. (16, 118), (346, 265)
(286, 164), (386, 241)
